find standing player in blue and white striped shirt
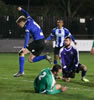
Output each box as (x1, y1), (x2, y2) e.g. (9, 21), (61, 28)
(45, 19), (76, 64)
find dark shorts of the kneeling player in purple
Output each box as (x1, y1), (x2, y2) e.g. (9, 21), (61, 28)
(62, 63), (81, 78)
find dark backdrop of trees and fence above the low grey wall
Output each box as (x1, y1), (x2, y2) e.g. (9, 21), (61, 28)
(0, 0), (94, 39)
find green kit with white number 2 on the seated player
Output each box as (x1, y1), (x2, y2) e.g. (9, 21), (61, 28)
(34, 68), (61, 94)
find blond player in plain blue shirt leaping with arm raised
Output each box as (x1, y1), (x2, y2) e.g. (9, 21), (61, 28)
(14, 7), (51, 77)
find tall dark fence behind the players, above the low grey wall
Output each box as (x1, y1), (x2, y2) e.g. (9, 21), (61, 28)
(0, 16), (94, 39)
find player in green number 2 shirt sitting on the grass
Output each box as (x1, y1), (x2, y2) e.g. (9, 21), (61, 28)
(34, 64), (67, 94)
